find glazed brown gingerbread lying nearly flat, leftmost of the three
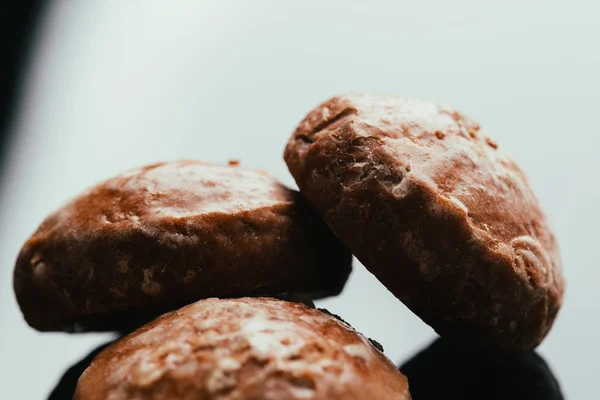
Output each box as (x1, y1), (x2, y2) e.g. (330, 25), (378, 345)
(14, 161), (351, 331)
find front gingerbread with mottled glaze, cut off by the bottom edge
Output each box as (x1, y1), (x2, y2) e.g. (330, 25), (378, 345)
(74, 298), (410, 400)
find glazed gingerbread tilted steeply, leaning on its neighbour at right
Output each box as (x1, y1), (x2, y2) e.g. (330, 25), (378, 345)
(284, 95), (564, 350)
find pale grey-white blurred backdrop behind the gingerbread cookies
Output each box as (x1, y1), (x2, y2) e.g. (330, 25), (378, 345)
(0, 0), (600, 399)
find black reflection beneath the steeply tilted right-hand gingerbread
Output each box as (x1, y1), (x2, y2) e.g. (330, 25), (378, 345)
(400, 339), (563, 400)
